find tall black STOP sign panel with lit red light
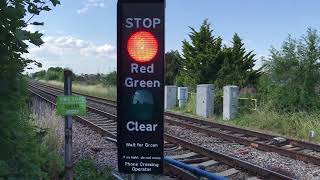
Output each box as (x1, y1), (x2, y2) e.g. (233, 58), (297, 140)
(117, 0), (164, 174)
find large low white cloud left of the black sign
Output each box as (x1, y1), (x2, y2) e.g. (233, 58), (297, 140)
(25, 36), (116, 74)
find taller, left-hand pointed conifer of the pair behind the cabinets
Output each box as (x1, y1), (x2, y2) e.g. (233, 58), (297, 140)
(177, 20), (223, 85)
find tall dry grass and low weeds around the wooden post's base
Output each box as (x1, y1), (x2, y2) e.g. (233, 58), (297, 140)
(30, 97), (112, 180)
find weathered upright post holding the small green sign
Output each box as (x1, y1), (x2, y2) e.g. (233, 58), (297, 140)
(64, 70), (73, 180)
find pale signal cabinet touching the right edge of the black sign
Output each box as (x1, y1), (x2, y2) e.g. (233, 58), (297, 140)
(165, 86), (177, 110)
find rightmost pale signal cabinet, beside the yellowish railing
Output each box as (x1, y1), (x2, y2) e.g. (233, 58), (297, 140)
(223, 86), (239, 120)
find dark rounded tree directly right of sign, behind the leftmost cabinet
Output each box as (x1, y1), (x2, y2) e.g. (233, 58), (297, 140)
(164, 50), (181, 85)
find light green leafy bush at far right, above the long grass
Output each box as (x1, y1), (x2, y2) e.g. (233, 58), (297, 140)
(260, 28), (320, 111)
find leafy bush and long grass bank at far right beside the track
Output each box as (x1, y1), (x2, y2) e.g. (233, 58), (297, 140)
(233, 28), (320, 142)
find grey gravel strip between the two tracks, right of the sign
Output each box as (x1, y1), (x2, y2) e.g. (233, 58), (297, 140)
(165, 124), (320, 180)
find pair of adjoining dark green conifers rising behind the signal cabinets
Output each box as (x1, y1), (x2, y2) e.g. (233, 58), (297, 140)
(176, 20), (260, 88)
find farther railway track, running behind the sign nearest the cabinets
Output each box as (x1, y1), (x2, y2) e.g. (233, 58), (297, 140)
(28, 83), (320, 165)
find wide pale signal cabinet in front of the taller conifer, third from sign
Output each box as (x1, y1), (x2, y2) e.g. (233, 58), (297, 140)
(196, 84), (214, 117)
